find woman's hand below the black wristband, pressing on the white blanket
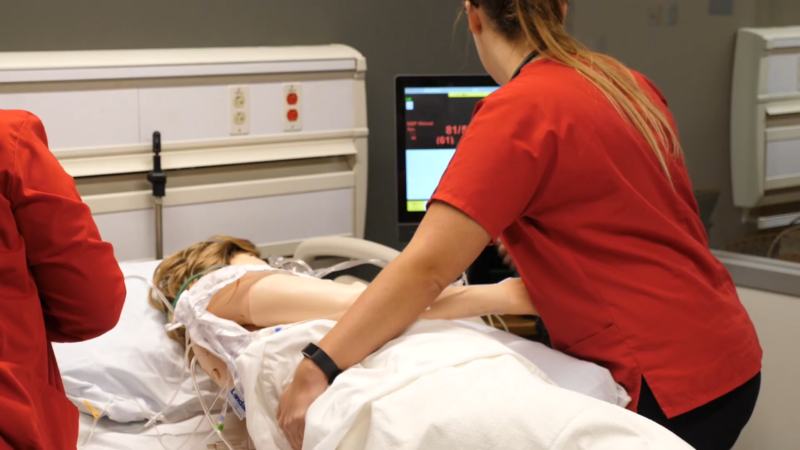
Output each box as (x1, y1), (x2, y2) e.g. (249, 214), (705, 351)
(278, 359), (328, 450)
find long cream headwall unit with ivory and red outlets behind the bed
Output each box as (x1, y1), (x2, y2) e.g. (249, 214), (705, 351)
(0, 45), (368, 261)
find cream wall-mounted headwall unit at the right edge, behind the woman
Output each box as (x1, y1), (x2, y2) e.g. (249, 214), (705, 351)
(731, 27), (800, 209)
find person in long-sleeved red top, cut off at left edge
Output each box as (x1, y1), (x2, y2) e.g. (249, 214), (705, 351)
(0, 110), (125, 450)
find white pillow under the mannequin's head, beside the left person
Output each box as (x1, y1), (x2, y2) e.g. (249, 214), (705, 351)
(53, 261), (219, 422)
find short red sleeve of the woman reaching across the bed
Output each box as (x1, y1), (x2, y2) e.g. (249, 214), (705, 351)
(424, 89), (557, 243)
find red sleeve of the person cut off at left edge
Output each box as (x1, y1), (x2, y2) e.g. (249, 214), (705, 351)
(9, 115), (125, 342)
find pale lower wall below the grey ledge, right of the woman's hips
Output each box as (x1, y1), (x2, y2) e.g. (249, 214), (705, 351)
(734, 288), (800, 450)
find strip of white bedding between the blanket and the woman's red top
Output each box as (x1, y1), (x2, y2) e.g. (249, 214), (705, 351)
(459, 321), (631, 408)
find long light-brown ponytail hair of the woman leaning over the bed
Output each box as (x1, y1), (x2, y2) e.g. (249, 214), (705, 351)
(469, 0), (683, 183)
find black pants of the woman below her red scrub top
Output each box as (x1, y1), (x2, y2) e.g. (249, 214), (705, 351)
(639, 374), (761, 450)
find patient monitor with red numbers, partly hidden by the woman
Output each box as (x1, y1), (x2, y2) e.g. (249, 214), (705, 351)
(395, 75), (498, 239)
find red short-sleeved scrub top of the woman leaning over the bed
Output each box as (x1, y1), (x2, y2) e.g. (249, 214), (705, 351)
(432, 59), (762, 417)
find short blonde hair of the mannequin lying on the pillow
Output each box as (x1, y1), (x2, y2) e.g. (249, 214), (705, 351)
(150, 236), (261, 344)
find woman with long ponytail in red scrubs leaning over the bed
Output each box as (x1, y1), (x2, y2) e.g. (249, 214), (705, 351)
(279, 0), (762, 450)
